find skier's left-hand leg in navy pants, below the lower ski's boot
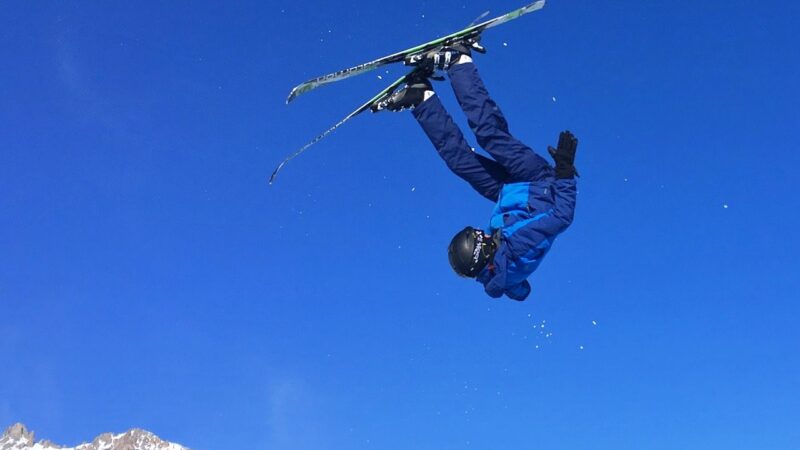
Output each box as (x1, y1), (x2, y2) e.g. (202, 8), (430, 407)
(412, 95), (507, 201)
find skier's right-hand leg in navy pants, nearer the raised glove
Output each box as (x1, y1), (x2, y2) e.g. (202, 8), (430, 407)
(448, 62), (553, 182)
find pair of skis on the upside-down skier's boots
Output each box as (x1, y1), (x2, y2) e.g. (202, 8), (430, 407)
(269, 0), (545, 184)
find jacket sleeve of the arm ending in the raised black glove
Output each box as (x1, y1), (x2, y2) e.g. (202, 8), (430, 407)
(503, 179), (578, 258)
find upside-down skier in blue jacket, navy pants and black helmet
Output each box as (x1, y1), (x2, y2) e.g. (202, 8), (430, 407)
(372, 39), (578, 301)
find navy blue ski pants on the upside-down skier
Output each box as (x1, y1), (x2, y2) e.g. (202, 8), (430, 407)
(412, 63), (553, 201)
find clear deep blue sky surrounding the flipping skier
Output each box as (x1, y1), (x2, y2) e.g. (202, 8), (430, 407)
(0, 0), (800, 450)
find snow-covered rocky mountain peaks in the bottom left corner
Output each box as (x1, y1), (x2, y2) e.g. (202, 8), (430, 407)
(0, 423), (189, 450)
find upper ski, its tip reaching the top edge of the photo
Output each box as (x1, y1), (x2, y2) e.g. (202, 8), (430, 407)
(286, 0), (545, 104)
